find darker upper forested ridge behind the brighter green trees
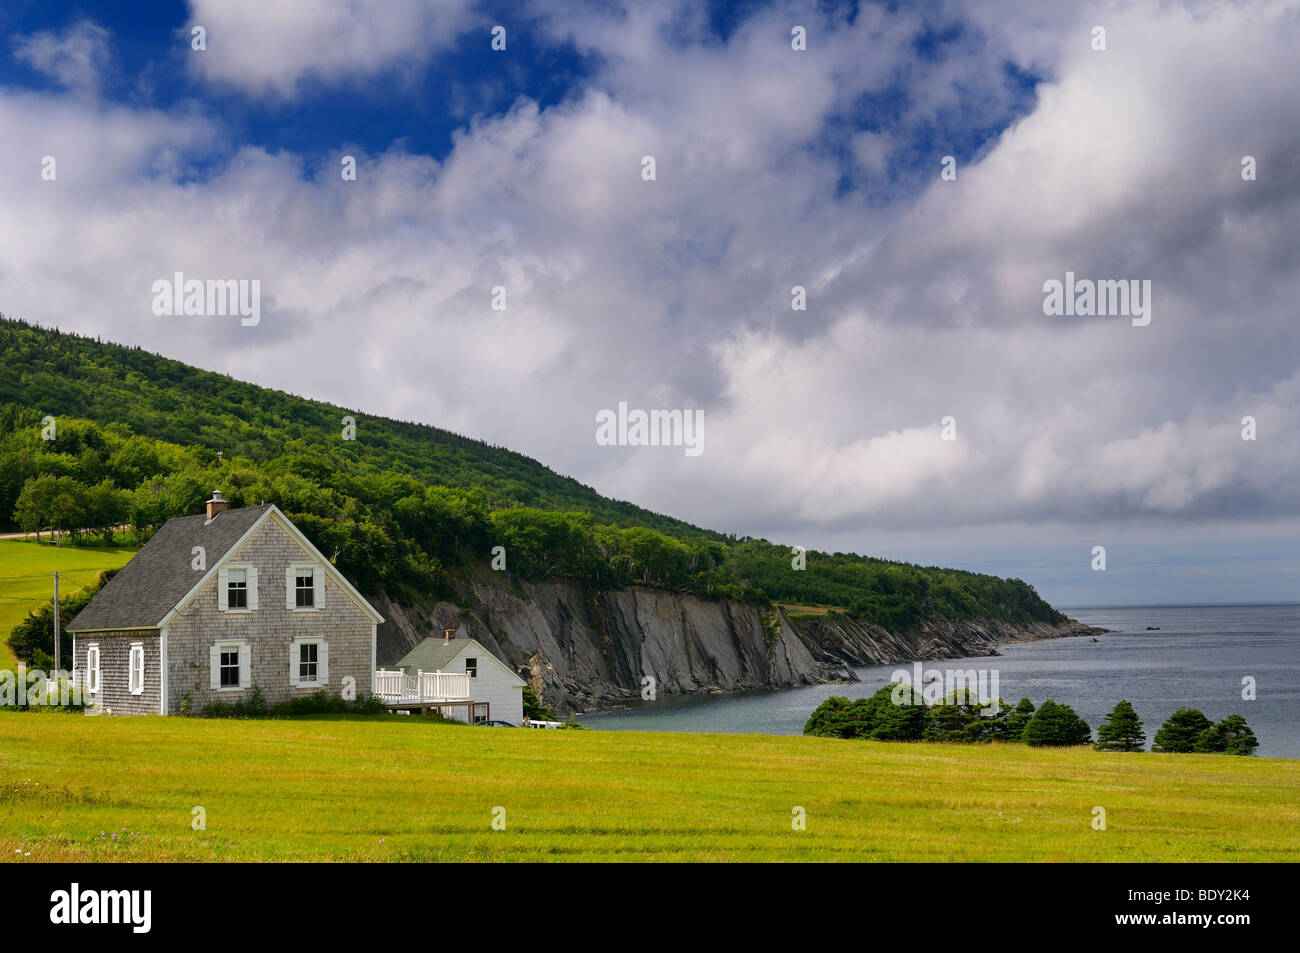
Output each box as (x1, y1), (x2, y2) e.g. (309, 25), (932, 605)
(0, 316), (722, 538)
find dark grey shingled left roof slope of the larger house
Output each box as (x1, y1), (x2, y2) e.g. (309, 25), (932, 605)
(68, 504), (270, 632)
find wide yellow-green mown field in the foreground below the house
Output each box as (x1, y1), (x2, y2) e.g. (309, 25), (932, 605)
(0, 712), (1300, 862)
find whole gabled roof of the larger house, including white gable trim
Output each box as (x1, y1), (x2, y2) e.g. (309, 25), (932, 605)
(68, 503), (384, 632)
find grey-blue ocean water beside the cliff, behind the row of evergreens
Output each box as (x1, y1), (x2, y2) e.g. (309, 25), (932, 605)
(579, 605), (1300, 758)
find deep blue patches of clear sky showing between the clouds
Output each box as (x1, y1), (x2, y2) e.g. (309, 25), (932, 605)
(0, 0), (1040, 191)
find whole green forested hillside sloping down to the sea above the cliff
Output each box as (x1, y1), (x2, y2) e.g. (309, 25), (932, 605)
(0, 319), (1065, 631)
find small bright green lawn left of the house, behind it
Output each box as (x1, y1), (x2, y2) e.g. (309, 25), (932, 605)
(0, 540), (135, 668)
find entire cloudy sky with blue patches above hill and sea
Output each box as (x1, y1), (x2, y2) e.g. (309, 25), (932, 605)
(0, 0), (1300, 605)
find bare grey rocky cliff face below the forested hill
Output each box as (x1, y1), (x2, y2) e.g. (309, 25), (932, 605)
(374, 572), (1096, 712)
